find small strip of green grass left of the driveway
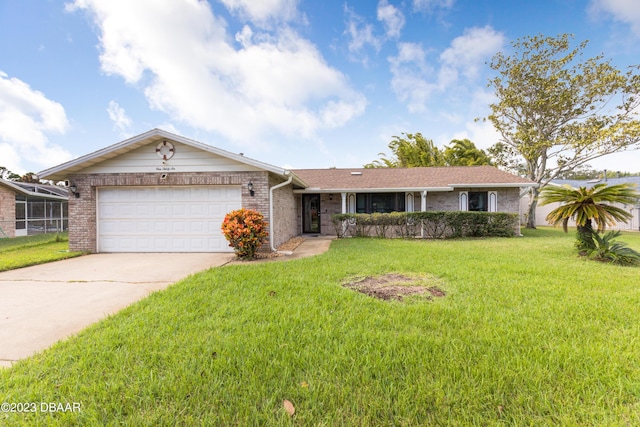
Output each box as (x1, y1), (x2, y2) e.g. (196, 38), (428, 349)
(0, 233), (82, 271)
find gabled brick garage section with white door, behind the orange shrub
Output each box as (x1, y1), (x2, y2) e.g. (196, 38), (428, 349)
(39, 129), (306, 253)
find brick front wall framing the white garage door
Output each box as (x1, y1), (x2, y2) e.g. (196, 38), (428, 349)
(69, 171), (270, 253)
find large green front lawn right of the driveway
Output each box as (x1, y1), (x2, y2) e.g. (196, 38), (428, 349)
(0, 229), (640, 426)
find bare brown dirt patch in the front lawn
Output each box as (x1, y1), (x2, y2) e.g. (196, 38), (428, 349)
(343, 273), (446, 301)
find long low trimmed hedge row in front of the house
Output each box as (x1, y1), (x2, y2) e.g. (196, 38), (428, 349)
(331, 211), (519, 239)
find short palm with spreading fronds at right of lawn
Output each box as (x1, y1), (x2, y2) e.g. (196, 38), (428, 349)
(540, 183), (640, 252)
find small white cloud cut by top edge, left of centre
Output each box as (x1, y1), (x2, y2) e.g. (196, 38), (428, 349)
(220, 0), (298, 26)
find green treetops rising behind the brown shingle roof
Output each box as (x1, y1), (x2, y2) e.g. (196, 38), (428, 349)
(364, 132), (491, 168)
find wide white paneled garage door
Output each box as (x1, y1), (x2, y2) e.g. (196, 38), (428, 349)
(97, 185), (241, 252)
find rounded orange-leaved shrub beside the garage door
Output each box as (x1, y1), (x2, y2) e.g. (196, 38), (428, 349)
(221, 208), (269, 259)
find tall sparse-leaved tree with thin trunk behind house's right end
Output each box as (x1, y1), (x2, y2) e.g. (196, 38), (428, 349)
(486, 34), (640, 228)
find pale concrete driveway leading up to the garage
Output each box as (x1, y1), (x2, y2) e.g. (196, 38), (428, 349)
(0, 253), (235, 367)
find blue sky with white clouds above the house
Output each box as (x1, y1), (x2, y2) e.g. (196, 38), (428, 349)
(0, 0), (640, 177)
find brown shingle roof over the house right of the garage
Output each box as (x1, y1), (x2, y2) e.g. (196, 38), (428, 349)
(292, 166), (535, 191)
